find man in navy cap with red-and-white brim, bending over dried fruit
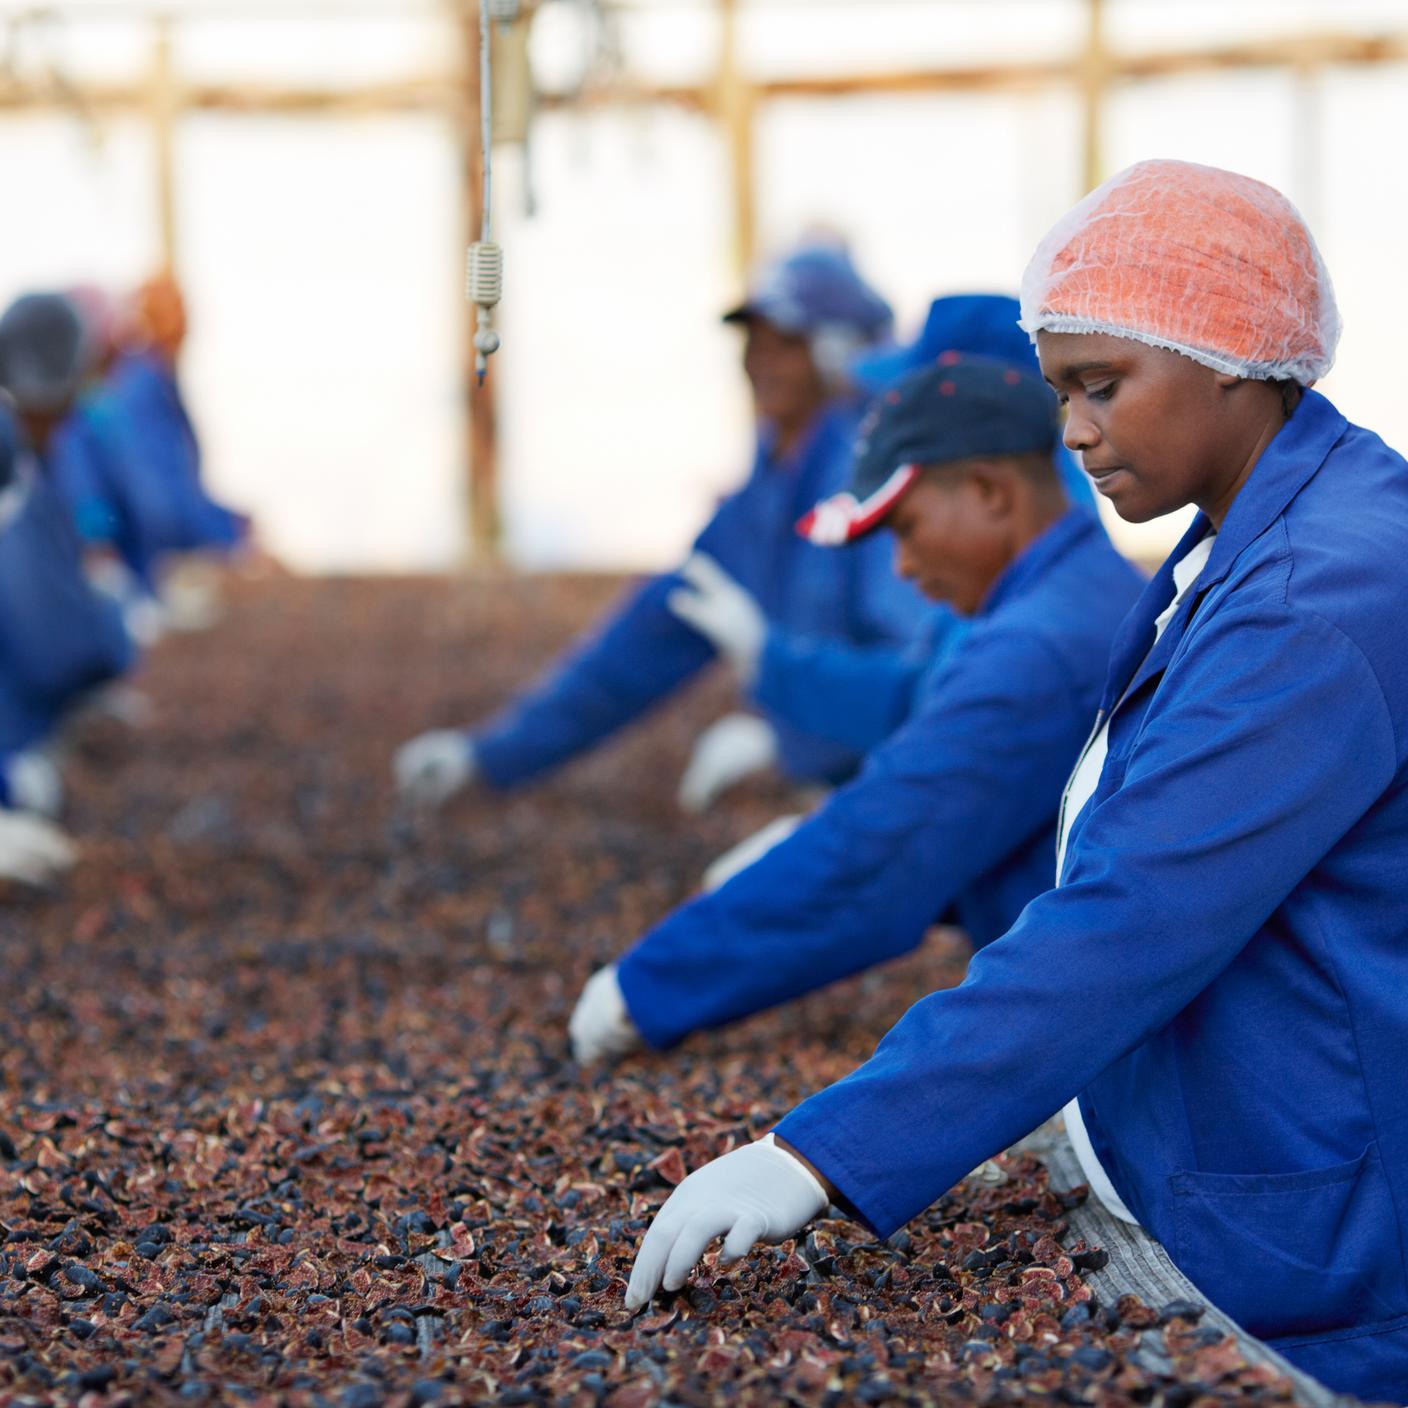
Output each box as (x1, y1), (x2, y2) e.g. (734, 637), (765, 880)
(572, 352), (1142, 1060)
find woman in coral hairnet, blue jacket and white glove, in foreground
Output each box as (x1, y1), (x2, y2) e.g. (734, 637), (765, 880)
(627, 162), (1408, 1401)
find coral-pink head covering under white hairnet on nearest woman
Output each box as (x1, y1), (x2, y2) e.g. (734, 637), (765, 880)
(1021, 161), (1340, 386)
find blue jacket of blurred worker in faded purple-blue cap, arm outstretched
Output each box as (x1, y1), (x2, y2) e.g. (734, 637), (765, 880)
(473, 404), (934, 787)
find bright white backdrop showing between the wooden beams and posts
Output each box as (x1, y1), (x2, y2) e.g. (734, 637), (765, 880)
(0, 0), (1408, 570)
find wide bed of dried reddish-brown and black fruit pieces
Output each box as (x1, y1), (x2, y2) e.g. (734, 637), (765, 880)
(0, 582), (1306, 1408)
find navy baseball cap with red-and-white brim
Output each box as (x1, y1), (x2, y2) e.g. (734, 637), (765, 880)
(797, 351), (1060, 548)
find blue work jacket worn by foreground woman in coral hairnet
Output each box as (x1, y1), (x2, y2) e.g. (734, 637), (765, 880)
(779, 393), (1408, 1402)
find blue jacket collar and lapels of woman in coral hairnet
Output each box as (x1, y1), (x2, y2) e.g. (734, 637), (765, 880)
(1100, 391), (1349, 718)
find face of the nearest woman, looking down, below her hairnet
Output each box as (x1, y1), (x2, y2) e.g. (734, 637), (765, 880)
(1036, 332), (1274, 522)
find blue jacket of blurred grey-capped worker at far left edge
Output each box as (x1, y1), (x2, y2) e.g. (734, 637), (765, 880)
(0, 456), (134, 758)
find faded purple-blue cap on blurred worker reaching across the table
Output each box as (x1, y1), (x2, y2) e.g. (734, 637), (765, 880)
(724, 245), (889, 342)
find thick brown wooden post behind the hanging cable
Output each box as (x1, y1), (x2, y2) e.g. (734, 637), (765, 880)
(458, 0), (501, 567)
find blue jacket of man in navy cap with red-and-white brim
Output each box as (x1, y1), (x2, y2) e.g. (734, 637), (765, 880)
(617, 508), (1143, 1046)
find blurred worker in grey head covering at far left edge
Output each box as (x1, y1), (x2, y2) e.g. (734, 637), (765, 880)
(0, 294), (135, 850)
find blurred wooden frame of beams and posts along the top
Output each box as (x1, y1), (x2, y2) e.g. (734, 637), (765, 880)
(0, 0), (1408, 563)
